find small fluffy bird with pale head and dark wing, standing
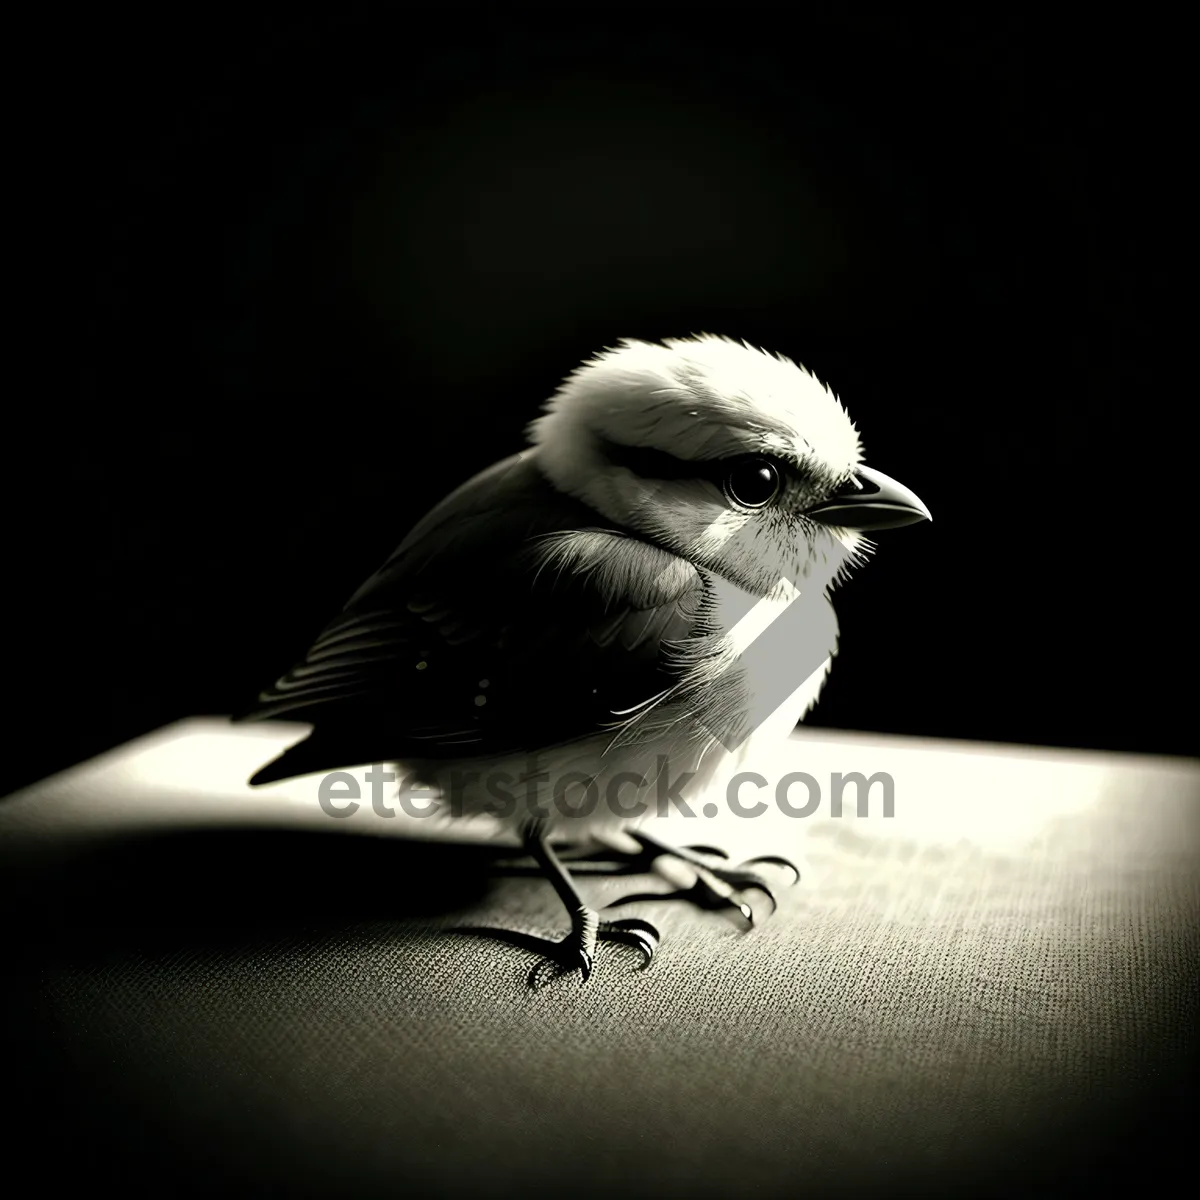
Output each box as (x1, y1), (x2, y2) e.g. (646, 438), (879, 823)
(238, 334), (931, 982)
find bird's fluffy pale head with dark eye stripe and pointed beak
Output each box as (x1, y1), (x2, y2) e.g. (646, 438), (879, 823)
(529, 335), (930, 595)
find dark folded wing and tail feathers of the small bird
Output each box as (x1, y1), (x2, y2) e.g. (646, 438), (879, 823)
(241, 451), (703, 782)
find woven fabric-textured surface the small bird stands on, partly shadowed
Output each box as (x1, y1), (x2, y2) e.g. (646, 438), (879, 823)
(0, 722), (1200, 1196)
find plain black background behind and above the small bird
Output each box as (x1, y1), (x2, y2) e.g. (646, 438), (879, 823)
(9, 14), (1192, 790)
